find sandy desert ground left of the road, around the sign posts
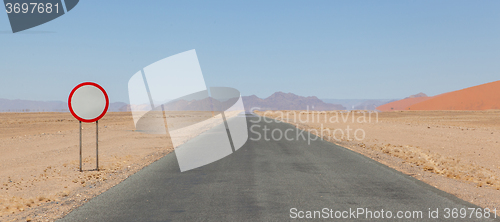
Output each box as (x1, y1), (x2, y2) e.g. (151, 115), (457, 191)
(0, 113), (173, 221)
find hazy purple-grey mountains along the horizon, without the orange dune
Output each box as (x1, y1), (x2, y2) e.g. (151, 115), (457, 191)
(0, 92), (414, 112)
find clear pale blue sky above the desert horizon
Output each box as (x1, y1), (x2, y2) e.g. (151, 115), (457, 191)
(0, 0), (500, 102)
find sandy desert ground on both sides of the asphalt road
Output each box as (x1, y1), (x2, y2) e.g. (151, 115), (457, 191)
(0, 111), (500, 221)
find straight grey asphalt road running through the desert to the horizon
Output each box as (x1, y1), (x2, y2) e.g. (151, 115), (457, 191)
(61, 117), (493, 221)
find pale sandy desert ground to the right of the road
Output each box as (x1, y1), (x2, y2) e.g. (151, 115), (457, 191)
(257, 111), (500, 214)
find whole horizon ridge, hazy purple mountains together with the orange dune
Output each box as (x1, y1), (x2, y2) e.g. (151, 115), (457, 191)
(6, 81), (500, 112)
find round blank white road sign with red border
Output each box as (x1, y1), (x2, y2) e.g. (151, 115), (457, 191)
(68, 82), (109, 123)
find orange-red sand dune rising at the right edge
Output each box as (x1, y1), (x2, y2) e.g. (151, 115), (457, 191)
(406, 81), (500, 110)
